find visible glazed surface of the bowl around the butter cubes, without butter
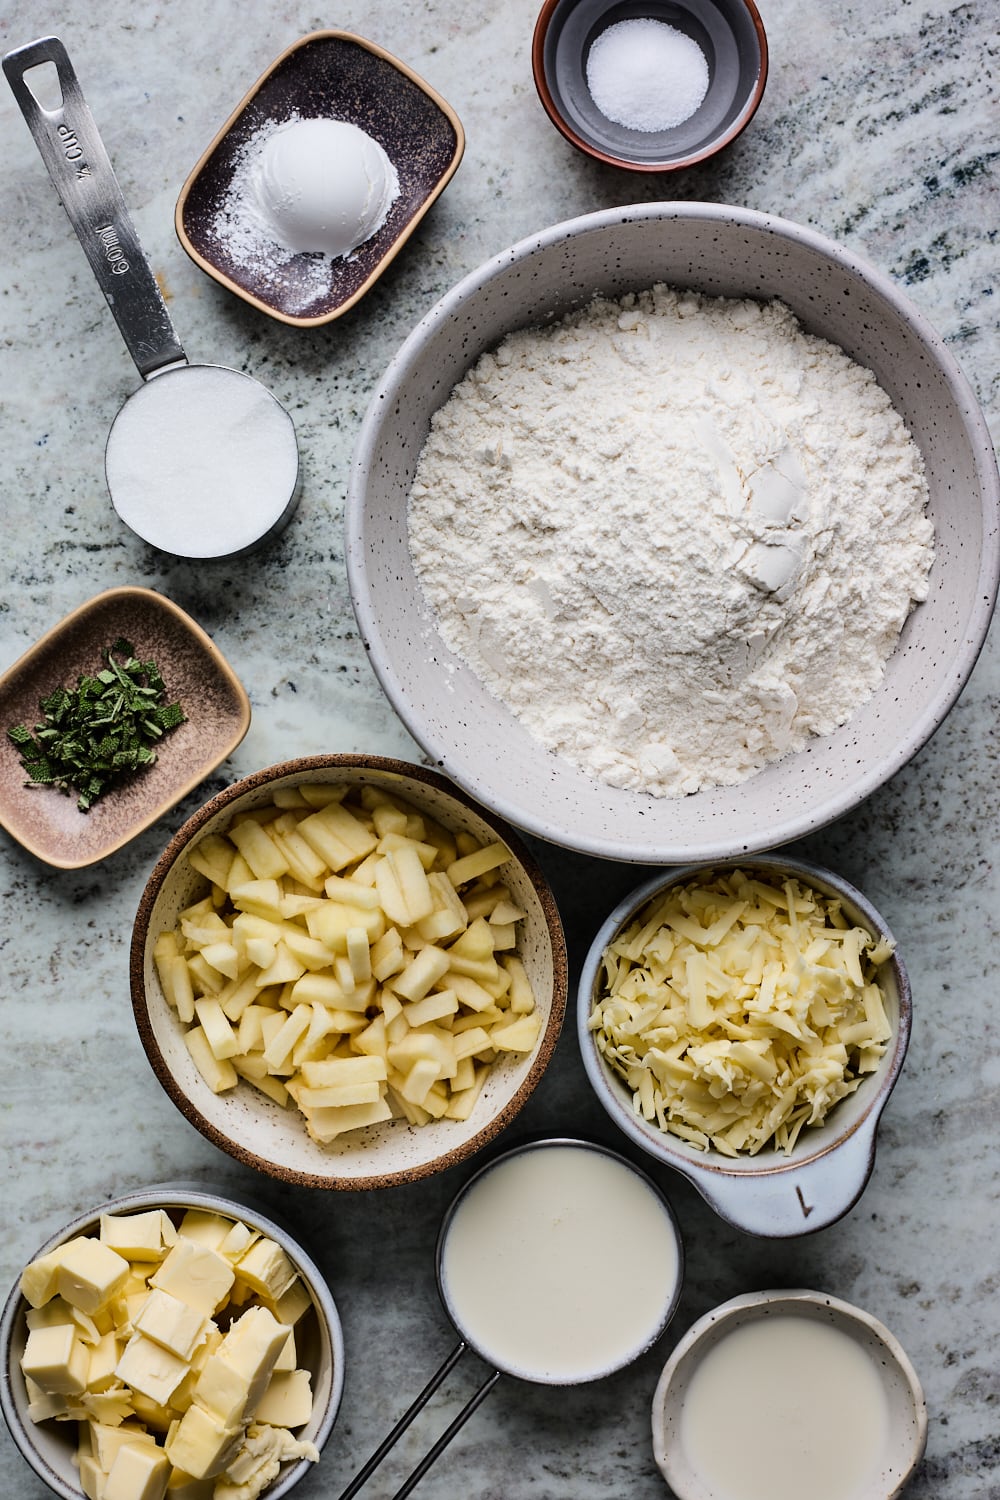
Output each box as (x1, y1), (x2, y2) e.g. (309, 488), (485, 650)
(0, 1182), (343, 1500)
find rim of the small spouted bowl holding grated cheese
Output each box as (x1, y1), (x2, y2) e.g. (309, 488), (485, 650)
(576, 854), (913, 1206)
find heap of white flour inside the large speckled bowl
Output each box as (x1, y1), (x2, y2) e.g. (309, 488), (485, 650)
(409, 287), (933, 797)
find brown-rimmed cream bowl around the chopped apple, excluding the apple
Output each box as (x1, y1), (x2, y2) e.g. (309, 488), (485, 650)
(130, 755), (567, 1188)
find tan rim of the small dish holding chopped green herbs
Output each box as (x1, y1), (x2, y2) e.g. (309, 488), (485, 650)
(0, 584), (252, 870)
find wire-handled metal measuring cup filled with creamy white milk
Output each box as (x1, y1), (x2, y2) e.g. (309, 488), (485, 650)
(339, 1137), (684, 1500)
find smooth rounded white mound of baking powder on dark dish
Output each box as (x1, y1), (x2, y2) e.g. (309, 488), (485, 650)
(249, 120), (399, 258)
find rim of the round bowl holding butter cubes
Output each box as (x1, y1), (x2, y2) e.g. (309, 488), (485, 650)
(0, 1179), (345, 1500)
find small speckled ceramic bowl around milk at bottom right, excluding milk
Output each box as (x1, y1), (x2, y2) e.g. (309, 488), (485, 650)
(652, 1289), (927, 1500)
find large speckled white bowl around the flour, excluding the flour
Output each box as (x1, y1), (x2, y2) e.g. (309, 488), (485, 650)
(346, 203), (1000, 864)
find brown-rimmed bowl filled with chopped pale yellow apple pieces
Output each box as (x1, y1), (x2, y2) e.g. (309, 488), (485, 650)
(130, 755), (567, 1188)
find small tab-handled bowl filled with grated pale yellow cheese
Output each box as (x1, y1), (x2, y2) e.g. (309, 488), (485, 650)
(577, 855), (912, 1239)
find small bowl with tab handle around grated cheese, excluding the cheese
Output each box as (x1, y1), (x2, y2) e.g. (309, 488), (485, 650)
(576, 855), (913, 1239)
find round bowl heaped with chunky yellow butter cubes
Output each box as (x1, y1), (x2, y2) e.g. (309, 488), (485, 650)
(0, 1184), (343, 1500)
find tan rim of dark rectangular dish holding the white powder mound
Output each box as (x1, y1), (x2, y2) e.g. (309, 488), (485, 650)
(174, 29), (465, 329)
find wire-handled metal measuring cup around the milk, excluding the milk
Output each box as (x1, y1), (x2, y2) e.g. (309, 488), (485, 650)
(339, 1137), (684, 1500)
